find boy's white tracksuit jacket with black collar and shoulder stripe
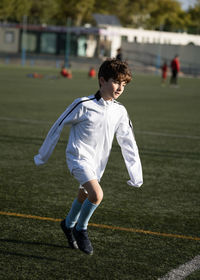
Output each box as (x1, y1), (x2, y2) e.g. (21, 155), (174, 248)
(34, 92), (143, 187)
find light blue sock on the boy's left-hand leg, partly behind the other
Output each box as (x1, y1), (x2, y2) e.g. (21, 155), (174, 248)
(65, 198), (82, 228)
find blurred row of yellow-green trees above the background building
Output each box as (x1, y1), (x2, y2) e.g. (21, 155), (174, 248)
(0, 0), (200, 33)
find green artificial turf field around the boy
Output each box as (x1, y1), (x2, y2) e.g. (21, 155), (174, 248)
(0, 66), (200, 280)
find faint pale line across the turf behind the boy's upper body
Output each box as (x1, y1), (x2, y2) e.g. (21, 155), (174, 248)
(0, 117), (200, 140)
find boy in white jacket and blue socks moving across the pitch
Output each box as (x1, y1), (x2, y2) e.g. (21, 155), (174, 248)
(34, 59), (143, 255)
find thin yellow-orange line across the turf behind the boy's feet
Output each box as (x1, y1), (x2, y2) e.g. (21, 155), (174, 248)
(0, 211), (200, 241)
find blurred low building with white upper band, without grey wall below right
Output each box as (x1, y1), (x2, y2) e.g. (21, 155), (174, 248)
(0, 14), (200, 57)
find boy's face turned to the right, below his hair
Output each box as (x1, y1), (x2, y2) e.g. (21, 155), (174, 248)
(99, 77), (126, 100)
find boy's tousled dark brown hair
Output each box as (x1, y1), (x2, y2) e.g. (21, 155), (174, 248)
(98, 59), (132, 83)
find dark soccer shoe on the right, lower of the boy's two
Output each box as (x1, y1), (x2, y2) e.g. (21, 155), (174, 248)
(73, 227), (93, 255)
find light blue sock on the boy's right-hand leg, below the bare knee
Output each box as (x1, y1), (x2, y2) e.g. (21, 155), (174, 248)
(76, 198), (98, 231)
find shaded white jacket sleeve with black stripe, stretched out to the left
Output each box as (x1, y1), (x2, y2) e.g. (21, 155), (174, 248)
(34, 99), (81, 165)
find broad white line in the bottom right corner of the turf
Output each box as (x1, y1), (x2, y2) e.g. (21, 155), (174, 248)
(158, 255), (200, 280)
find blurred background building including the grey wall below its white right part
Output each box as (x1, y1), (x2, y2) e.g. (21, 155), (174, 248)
(0, 18), (200, 73)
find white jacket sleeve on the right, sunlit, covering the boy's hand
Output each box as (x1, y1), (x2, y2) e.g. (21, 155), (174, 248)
(116, 112), (143, 188)
